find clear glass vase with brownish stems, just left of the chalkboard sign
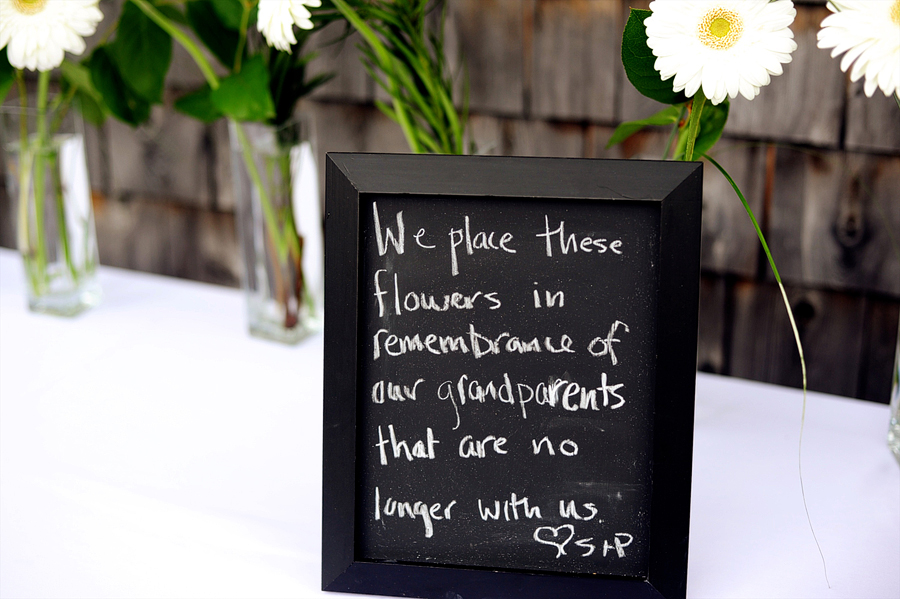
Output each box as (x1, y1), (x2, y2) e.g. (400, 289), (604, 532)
(229, 117), (323, 343)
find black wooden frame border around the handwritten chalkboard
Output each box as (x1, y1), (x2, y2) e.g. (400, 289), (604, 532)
(322, 153), (702, 599)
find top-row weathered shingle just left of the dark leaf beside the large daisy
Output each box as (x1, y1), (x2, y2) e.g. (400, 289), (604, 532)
(531, 0), (622, 122)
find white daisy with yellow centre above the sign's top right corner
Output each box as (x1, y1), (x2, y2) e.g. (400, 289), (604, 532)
(644, 0), (797, 104)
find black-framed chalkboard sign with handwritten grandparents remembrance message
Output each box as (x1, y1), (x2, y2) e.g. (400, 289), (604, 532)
(323, 154), (702, 599)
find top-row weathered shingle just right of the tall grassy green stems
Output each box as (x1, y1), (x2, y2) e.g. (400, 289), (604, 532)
(446, 0), (533, 116)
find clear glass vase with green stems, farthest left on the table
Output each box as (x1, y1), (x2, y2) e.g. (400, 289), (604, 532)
(0, 107), (101, 316)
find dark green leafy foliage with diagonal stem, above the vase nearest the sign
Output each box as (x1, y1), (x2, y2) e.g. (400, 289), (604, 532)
(87, 0), (338, 126)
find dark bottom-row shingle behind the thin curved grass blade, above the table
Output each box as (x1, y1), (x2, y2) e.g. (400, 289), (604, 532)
(730, 282), (865, 397)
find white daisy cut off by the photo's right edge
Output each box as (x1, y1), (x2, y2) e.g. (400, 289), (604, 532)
(818, 0), (900, 98)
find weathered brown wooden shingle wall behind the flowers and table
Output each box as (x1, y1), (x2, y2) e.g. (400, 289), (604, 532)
(0, 0), (900, 401)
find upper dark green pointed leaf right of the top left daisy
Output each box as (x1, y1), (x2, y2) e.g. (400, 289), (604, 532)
(110, 2), (172, 104)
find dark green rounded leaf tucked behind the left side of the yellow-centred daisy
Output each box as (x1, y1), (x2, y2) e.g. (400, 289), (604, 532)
(622, 8), (688, 104)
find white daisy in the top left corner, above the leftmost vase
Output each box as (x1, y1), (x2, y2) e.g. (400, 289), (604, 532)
(0, 0), (103, 71)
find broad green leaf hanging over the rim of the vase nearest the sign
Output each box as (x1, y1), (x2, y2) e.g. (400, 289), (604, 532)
(210, 55), (275, 121)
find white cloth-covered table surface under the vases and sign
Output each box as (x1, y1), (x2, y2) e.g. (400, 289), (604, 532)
(0, 250), (900, 599)
